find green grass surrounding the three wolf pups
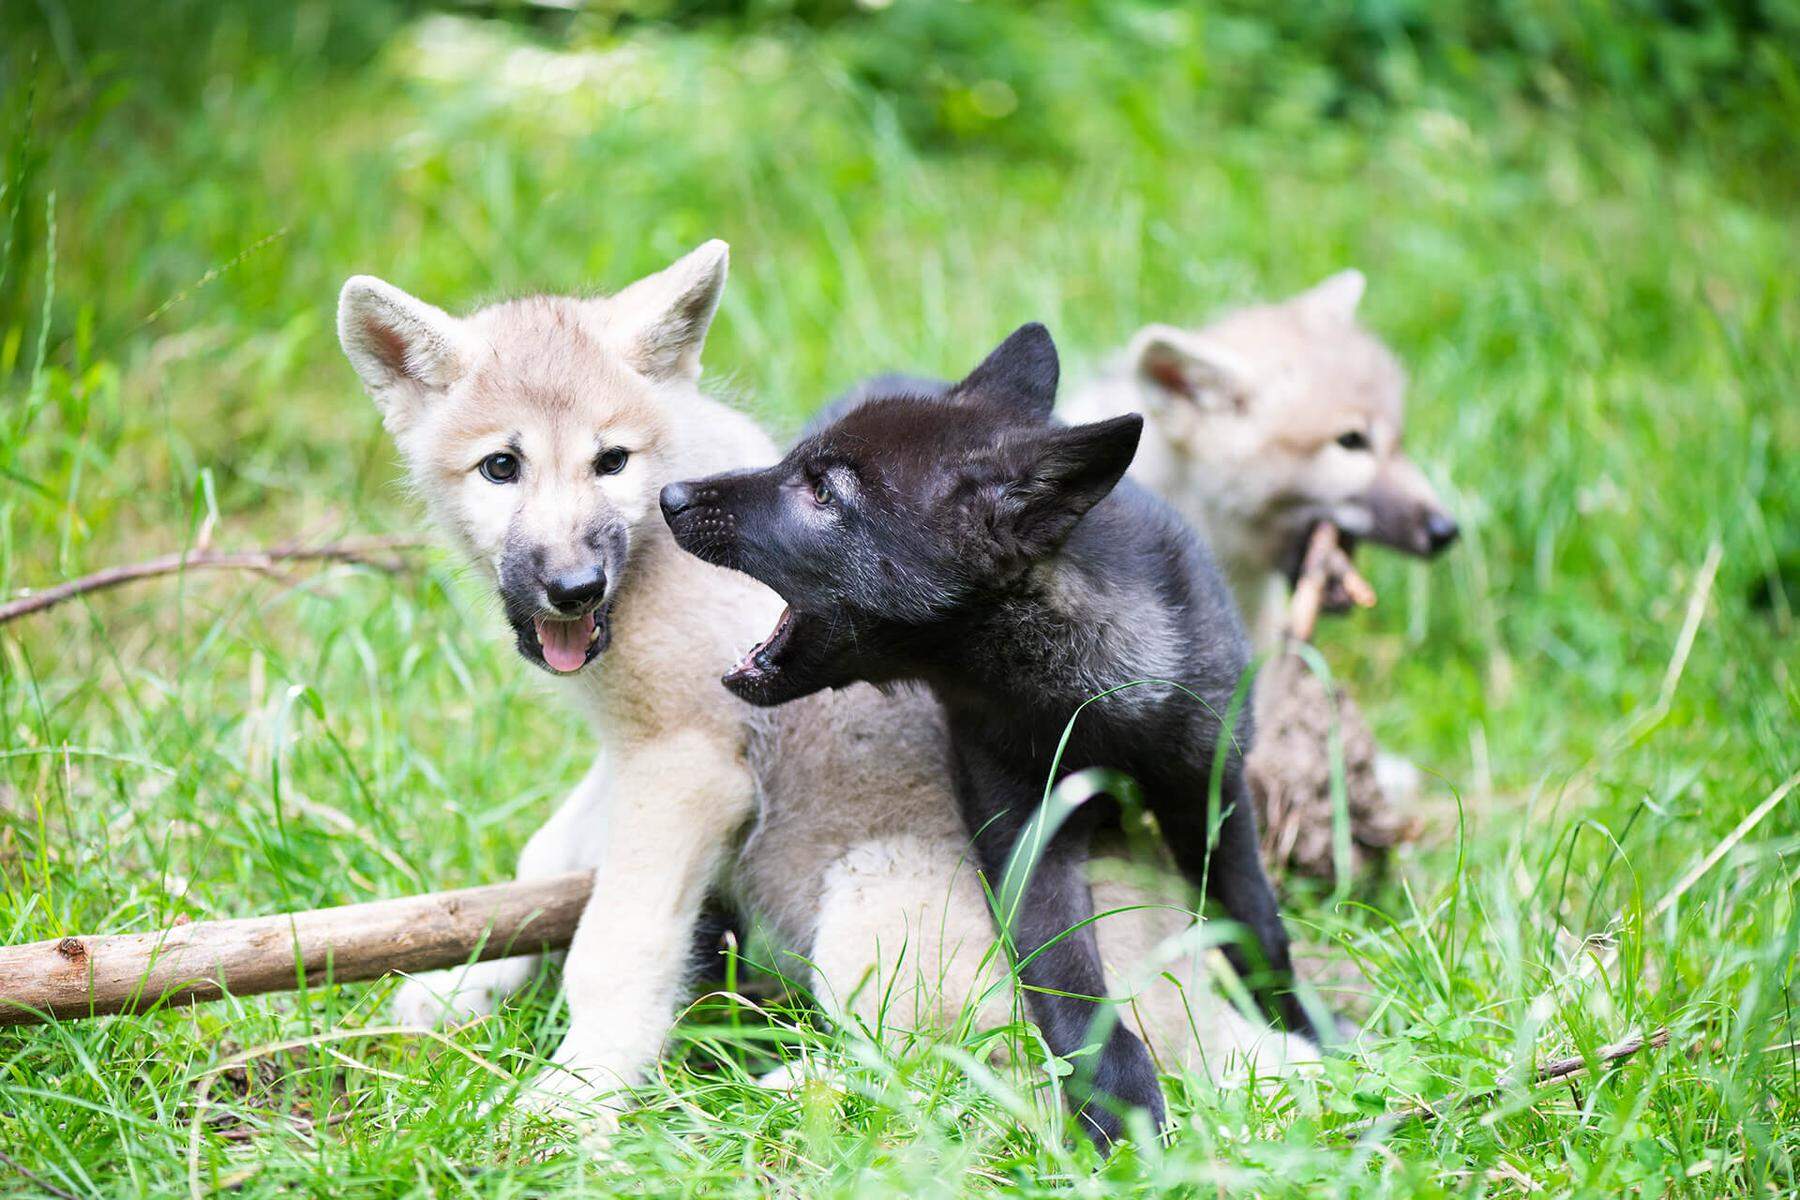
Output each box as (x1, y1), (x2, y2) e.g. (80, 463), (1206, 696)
(0, 5), (1800, 1196)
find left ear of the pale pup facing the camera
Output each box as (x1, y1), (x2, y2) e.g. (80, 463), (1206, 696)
(338, 275), (464, 416)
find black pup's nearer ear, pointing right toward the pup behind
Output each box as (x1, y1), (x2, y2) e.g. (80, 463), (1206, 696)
(995, 412), (1143, 561)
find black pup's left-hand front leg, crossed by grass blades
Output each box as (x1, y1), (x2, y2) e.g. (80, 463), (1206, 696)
(952, 741), (1163, 1151)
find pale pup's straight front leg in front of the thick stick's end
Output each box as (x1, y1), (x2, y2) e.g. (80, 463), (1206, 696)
(535, 730), (754, 1106)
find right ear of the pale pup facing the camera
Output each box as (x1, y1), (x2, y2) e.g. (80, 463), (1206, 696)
(601, 237), (731, 380)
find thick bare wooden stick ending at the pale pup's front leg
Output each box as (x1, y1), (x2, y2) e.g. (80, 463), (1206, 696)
(0, 871), (594, 1025)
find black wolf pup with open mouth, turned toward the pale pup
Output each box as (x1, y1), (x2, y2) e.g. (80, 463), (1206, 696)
(662, 324), (1310, 1150)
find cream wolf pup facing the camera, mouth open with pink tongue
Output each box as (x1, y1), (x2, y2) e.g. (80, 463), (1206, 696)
(338, 241), (1310, 1119)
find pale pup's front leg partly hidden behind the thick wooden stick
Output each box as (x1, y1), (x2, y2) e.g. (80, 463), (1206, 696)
(394, 752), (607, 1025)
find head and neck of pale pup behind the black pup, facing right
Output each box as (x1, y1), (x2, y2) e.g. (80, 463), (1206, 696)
(1060, 270), (1458, 649)
